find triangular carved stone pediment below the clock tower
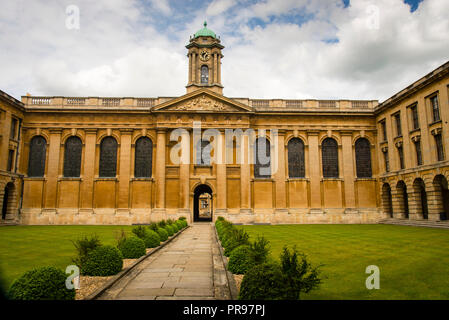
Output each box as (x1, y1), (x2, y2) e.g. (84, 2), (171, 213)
(151, 89), (253, 113)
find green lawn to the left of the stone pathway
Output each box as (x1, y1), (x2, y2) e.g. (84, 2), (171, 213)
(0, 226), (133, 288)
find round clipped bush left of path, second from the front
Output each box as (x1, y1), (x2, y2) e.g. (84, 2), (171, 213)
(81, 246), (123, 277)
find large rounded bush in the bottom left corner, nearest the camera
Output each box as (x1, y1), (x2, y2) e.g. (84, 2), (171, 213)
(8, 267), (75, 300)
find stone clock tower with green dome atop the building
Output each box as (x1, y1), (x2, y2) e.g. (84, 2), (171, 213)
(186, 21), (224, 94)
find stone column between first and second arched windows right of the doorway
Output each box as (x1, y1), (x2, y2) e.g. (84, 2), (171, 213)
(271, 130), (288, 213)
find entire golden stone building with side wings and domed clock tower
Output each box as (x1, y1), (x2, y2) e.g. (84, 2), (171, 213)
(0, 25), (449, 224)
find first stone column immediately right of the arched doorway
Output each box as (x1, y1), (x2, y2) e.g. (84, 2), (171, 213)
(214, 130), (227, 212)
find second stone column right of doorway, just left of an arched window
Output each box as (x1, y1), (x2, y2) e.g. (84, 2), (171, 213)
(240, 134), (251, 213)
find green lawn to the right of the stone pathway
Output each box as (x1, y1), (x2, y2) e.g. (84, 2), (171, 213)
(234, 225), (449, 299)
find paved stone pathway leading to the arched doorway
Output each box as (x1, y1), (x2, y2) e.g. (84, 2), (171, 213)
(100, 223), (227, 300)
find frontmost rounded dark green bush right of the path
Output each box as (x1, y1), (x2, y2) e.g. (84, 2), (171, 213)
(238, 263), (289, 300)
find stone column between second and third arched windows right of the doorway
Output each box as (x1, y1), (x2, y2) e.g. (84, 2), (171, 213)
(307, 131), (322, 212)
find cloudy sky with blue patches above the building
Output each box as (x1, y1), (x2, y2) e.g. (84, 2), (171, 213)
(0, 0), (449, 101)
